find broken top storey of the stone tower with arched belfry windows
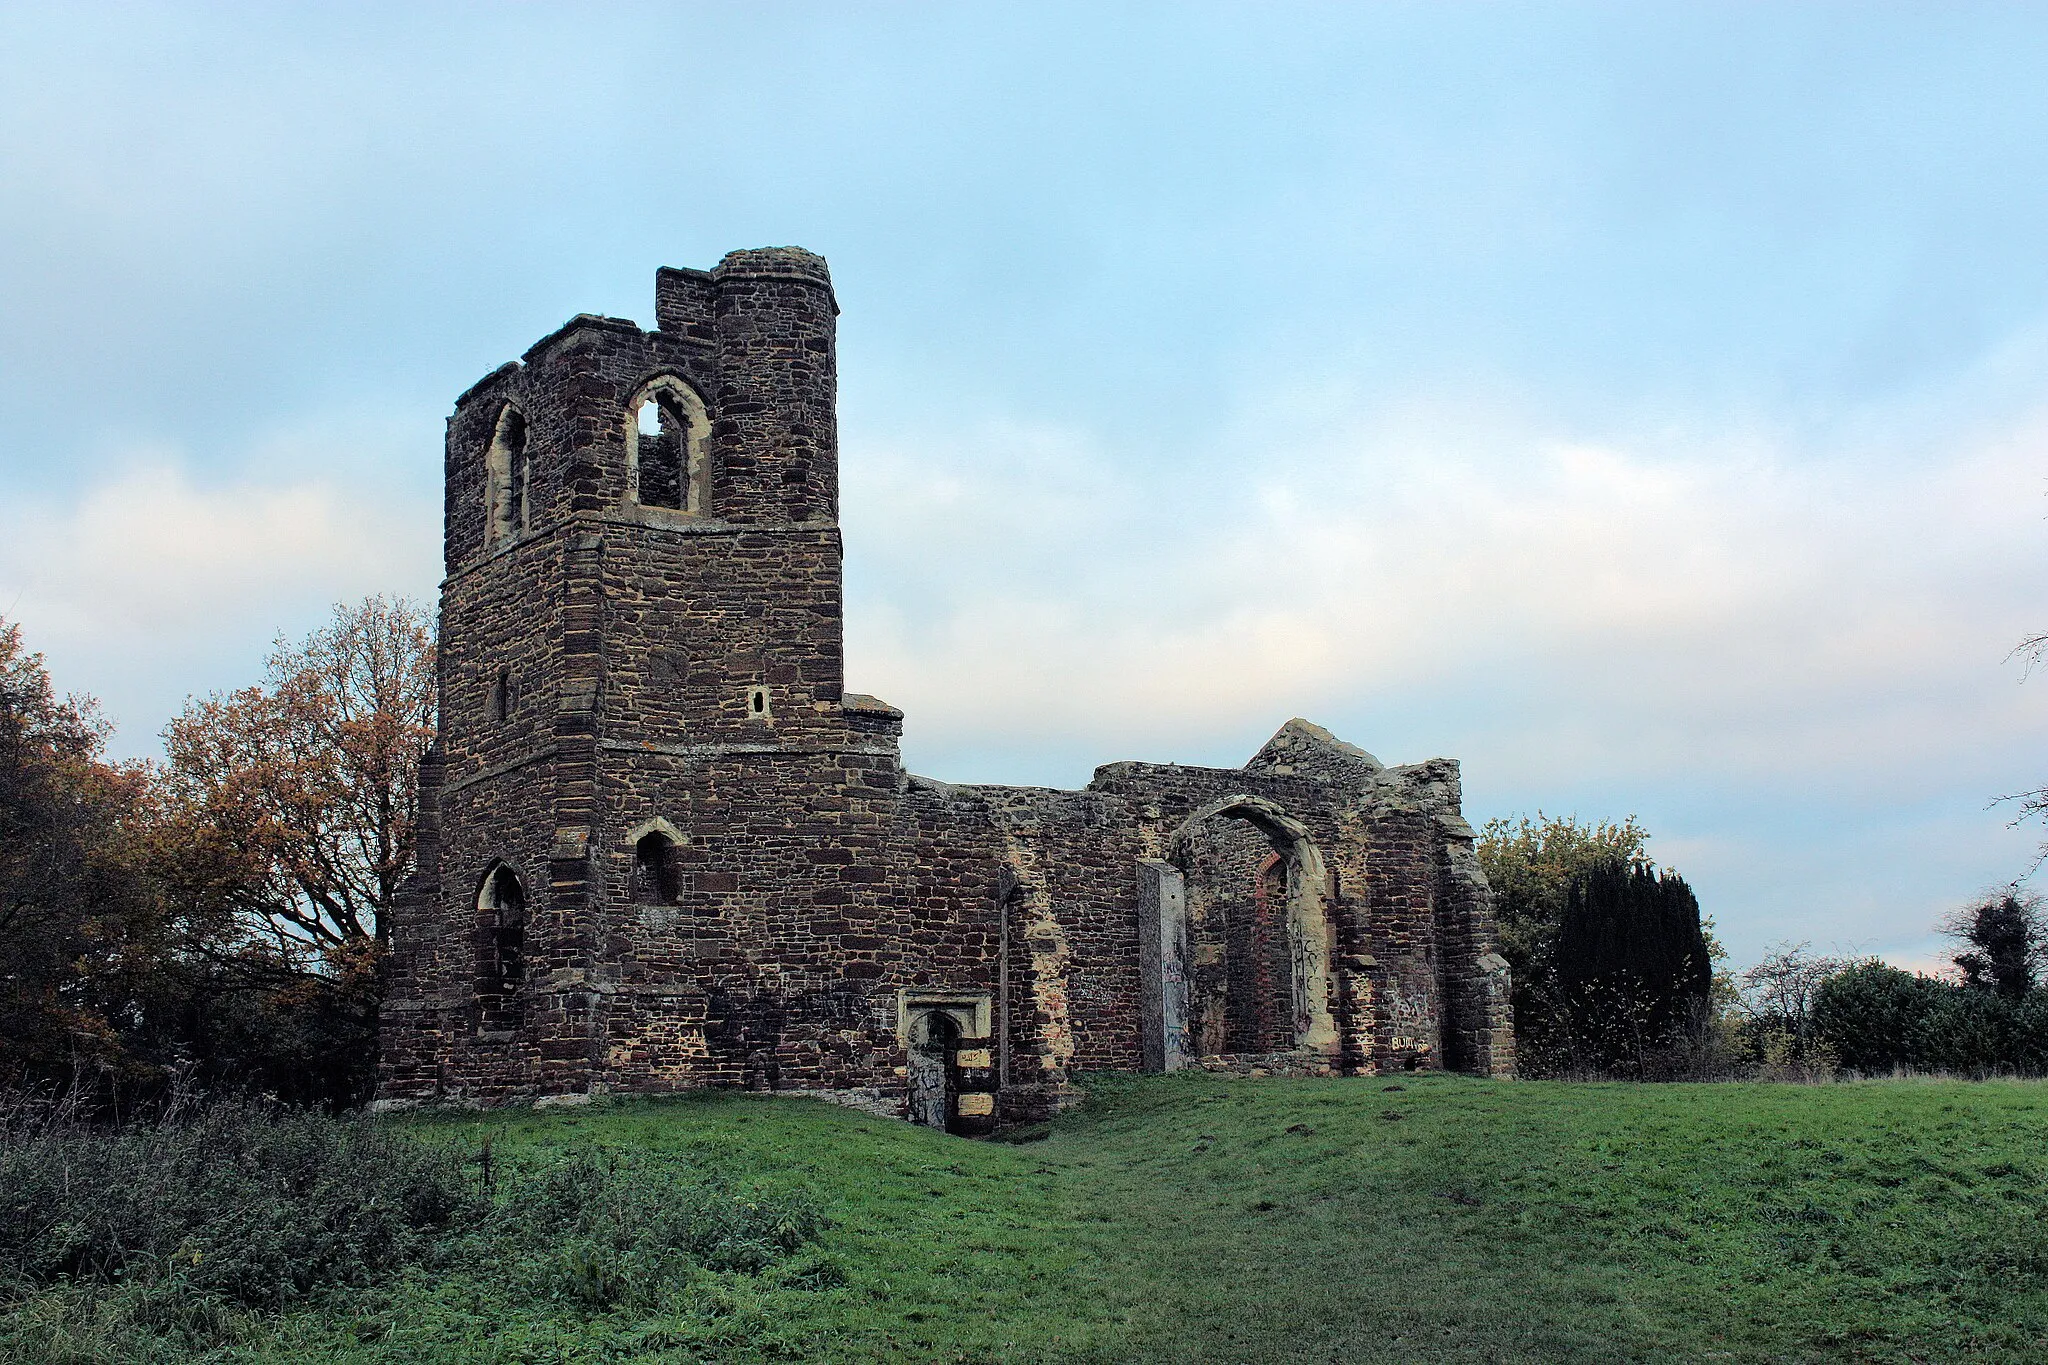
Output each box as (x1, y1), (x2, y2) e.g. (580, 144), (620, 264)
(444, 248), (840, 575)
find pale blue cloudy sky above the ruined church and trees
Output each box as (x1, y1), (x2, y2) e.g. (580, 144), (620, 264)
(0, 4), (2048, 962)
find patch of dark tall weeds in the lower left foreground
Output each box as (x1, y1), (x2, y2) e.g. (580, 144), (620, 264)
(0, 1099), (825, 1361)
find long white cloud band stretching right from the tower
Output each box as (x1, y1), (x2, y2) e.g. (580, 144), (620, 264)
(846, 388), (2048, 776)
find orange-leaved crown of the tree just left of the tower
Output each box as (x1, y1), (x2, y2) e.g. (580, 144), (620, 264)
(160, 596), (436, 970)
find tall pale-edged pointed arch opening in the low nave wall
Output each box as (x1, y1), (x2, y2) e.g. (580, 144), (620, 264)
(1143, 796), (1337, 1068)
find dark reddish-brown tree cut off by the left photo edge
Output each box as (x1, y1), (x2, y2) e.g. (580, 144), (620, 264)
(0, 620), (162, 1085)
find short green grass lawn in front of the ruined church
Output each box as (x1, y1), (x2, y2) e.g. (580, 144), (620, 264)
(14, 1076), (2048, 1363)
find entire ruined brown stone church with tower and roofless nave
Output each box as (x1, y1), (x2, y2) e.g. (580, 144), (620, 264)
(379, 248), (1513, 1132)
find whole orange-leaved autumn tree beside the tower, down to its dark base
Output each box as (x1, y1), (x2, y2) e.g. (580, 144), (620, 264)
(154, 598), (436, 1103)
